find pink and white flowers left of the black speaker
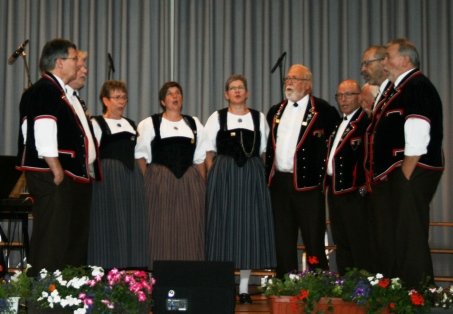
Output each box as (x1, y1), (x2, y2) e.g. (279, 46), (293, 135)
(31, 266), (154, 314)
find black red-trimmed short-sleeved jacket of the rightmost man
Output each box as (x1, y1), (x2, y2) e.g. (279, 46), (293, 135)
(367, 69), (444, 180)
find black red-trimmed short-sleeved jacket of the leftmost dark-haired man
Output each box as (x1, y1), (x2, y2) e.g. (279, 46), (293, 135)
(18, 73), (100, 183)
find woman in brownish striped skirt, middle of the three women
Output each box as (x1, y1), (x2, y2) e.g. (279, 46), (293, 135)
(135, 82), (206, 269)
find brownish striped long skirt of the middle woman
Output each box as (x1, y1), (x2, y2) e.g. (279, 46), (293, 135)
(145, 164), (206, 269)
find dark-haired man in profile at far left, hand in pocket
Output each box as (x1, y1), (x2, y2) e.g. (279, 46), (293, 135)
(19, 39), (99, 275)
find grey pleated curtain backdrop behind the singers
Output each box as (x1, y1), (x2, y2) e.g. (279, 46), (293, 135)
(0, 0), (453, 276)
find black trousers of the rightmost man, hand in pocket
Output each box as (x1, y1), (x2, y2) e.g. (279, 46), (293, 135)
(369, 167), (442, 287)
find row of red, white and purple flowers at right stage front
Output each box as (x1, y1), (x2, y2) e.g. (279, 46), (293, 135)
(262, 269), (453, 314)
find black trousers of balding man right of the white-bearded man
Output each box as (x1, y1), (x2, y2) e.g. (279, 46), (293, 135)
(327, 186), (372, 275)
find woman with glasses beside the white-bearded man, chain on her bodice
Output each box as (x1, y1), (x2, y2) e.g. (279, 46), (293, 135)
(205, 75), (275, 303)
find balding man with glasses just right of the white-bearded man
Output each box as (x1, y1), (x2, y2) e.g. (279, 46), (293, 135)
(326, 80), (371, 275)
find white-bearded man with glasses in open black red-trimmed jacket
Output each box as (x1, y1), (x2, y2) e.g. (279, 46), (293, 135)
(266, 64), (339, 277)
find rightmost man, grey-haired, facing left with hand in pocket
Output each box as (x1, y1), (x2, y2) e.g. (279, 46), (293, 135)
(365, 39), (444, 287)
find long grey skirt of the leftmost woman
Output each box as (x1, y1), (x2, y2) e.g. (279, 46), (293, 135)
(88, 159), (148, 268)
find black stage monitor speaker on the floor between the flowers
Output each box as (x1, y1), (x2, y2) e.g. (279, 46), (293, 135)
(153, 261), (236, 314)
